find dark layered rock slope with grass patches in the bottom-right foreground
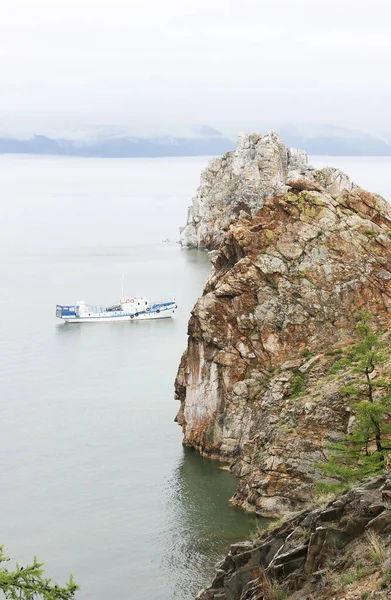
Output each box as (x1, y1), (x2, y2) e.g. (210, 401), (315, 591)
(197, 473), (391, 600)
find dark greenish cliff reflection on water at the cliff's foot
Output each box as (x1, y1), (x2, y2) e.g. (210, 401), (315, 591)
(162, 448), (267, 600)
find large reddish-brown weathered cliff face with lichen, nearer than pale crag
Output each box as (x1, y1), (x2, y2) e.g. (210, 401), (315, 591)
(176, 159), (391, 516)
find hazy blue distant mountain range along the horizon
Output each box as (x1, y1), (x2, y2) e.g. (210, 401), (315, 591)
(0, 126), (391, 158)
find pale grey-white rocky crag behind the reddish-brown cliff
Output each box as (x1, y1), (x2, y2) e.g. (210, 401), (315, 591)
(181, 131), (308, 250)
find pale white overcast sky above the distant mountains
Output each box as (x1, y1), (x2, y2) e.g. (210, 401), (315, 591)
(0, 0), (391, 133)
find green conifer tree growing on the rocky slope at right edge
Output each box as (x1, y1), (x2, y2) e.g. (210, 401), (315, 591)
(317, 311), (391, 491)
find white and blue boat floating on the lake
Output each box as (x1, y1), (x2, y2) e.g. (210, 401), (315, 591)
(56, 298), (178, 323)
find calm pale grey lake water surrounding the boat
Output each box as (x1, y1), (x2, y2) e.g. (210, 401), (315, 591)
(0, 156), (391, 600)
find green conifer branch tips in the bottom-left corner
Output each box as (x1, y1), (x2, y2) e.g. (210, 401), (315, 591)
(0, 546), (79, 600)
